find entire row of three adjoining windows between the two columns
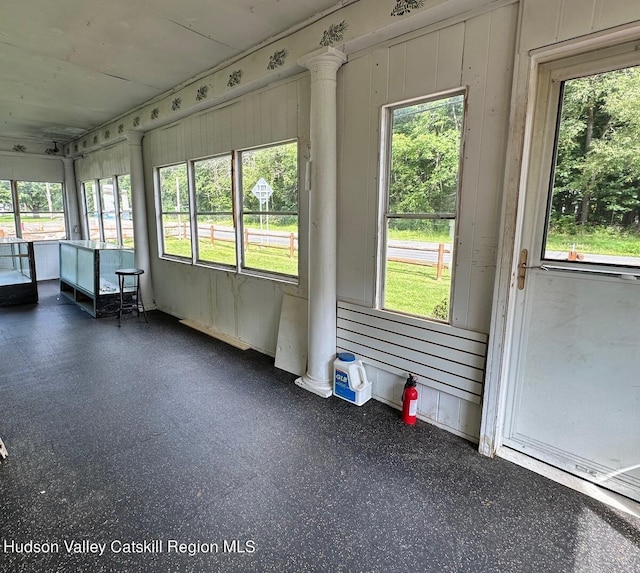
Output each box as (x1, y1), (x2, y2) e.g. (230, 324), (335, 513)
(156, 141), (298, 277)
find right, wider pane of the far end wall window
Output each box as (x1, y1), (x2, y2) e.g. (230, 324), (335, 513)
(16, 181), (66, 241)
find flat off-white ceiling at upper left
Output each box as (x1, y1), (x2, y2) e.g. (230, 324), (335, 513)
(0, 0), (356, 150)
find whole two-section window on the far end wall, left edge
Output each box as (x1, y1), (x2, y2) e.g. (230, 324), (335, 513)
(0, 180), (67, 241)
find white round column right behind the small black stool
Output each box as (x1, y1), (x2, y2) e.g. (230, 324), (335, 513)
(127, 131), (155, 310)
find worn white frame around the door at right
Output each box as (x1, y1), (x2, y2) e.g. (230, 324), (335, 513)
(478, 22), (640, 516)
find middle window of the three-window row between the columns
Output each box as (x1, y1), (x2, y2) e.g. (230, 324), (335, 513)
(193, 154), (236, 266)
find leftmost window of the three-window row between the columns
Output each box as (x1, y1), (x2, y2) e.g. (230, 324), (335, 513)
(157, 163), (193, 259)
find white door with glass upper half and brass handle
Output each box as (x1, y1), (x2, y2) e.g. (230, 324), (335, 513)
(503, 45), (640, 501)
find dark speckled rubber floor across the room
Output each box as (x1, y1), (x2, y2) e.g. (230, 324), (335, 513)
(0, 283), (640, 573)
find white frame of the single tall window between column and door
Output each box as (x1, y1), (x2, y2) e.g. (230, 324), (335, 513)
(374, 86), (469, 325)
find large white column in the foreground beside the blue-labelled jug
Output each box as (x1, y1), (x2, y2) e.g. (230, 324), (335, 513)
(296, 47), (346, 398)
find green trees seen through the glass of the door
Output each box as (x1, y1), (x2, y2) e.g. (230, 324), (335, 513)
(552, 68), (640, 226)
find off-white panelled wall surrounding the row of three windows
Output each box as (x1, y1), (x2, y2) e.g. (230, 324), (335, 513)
(143, 75), (310, 356)
